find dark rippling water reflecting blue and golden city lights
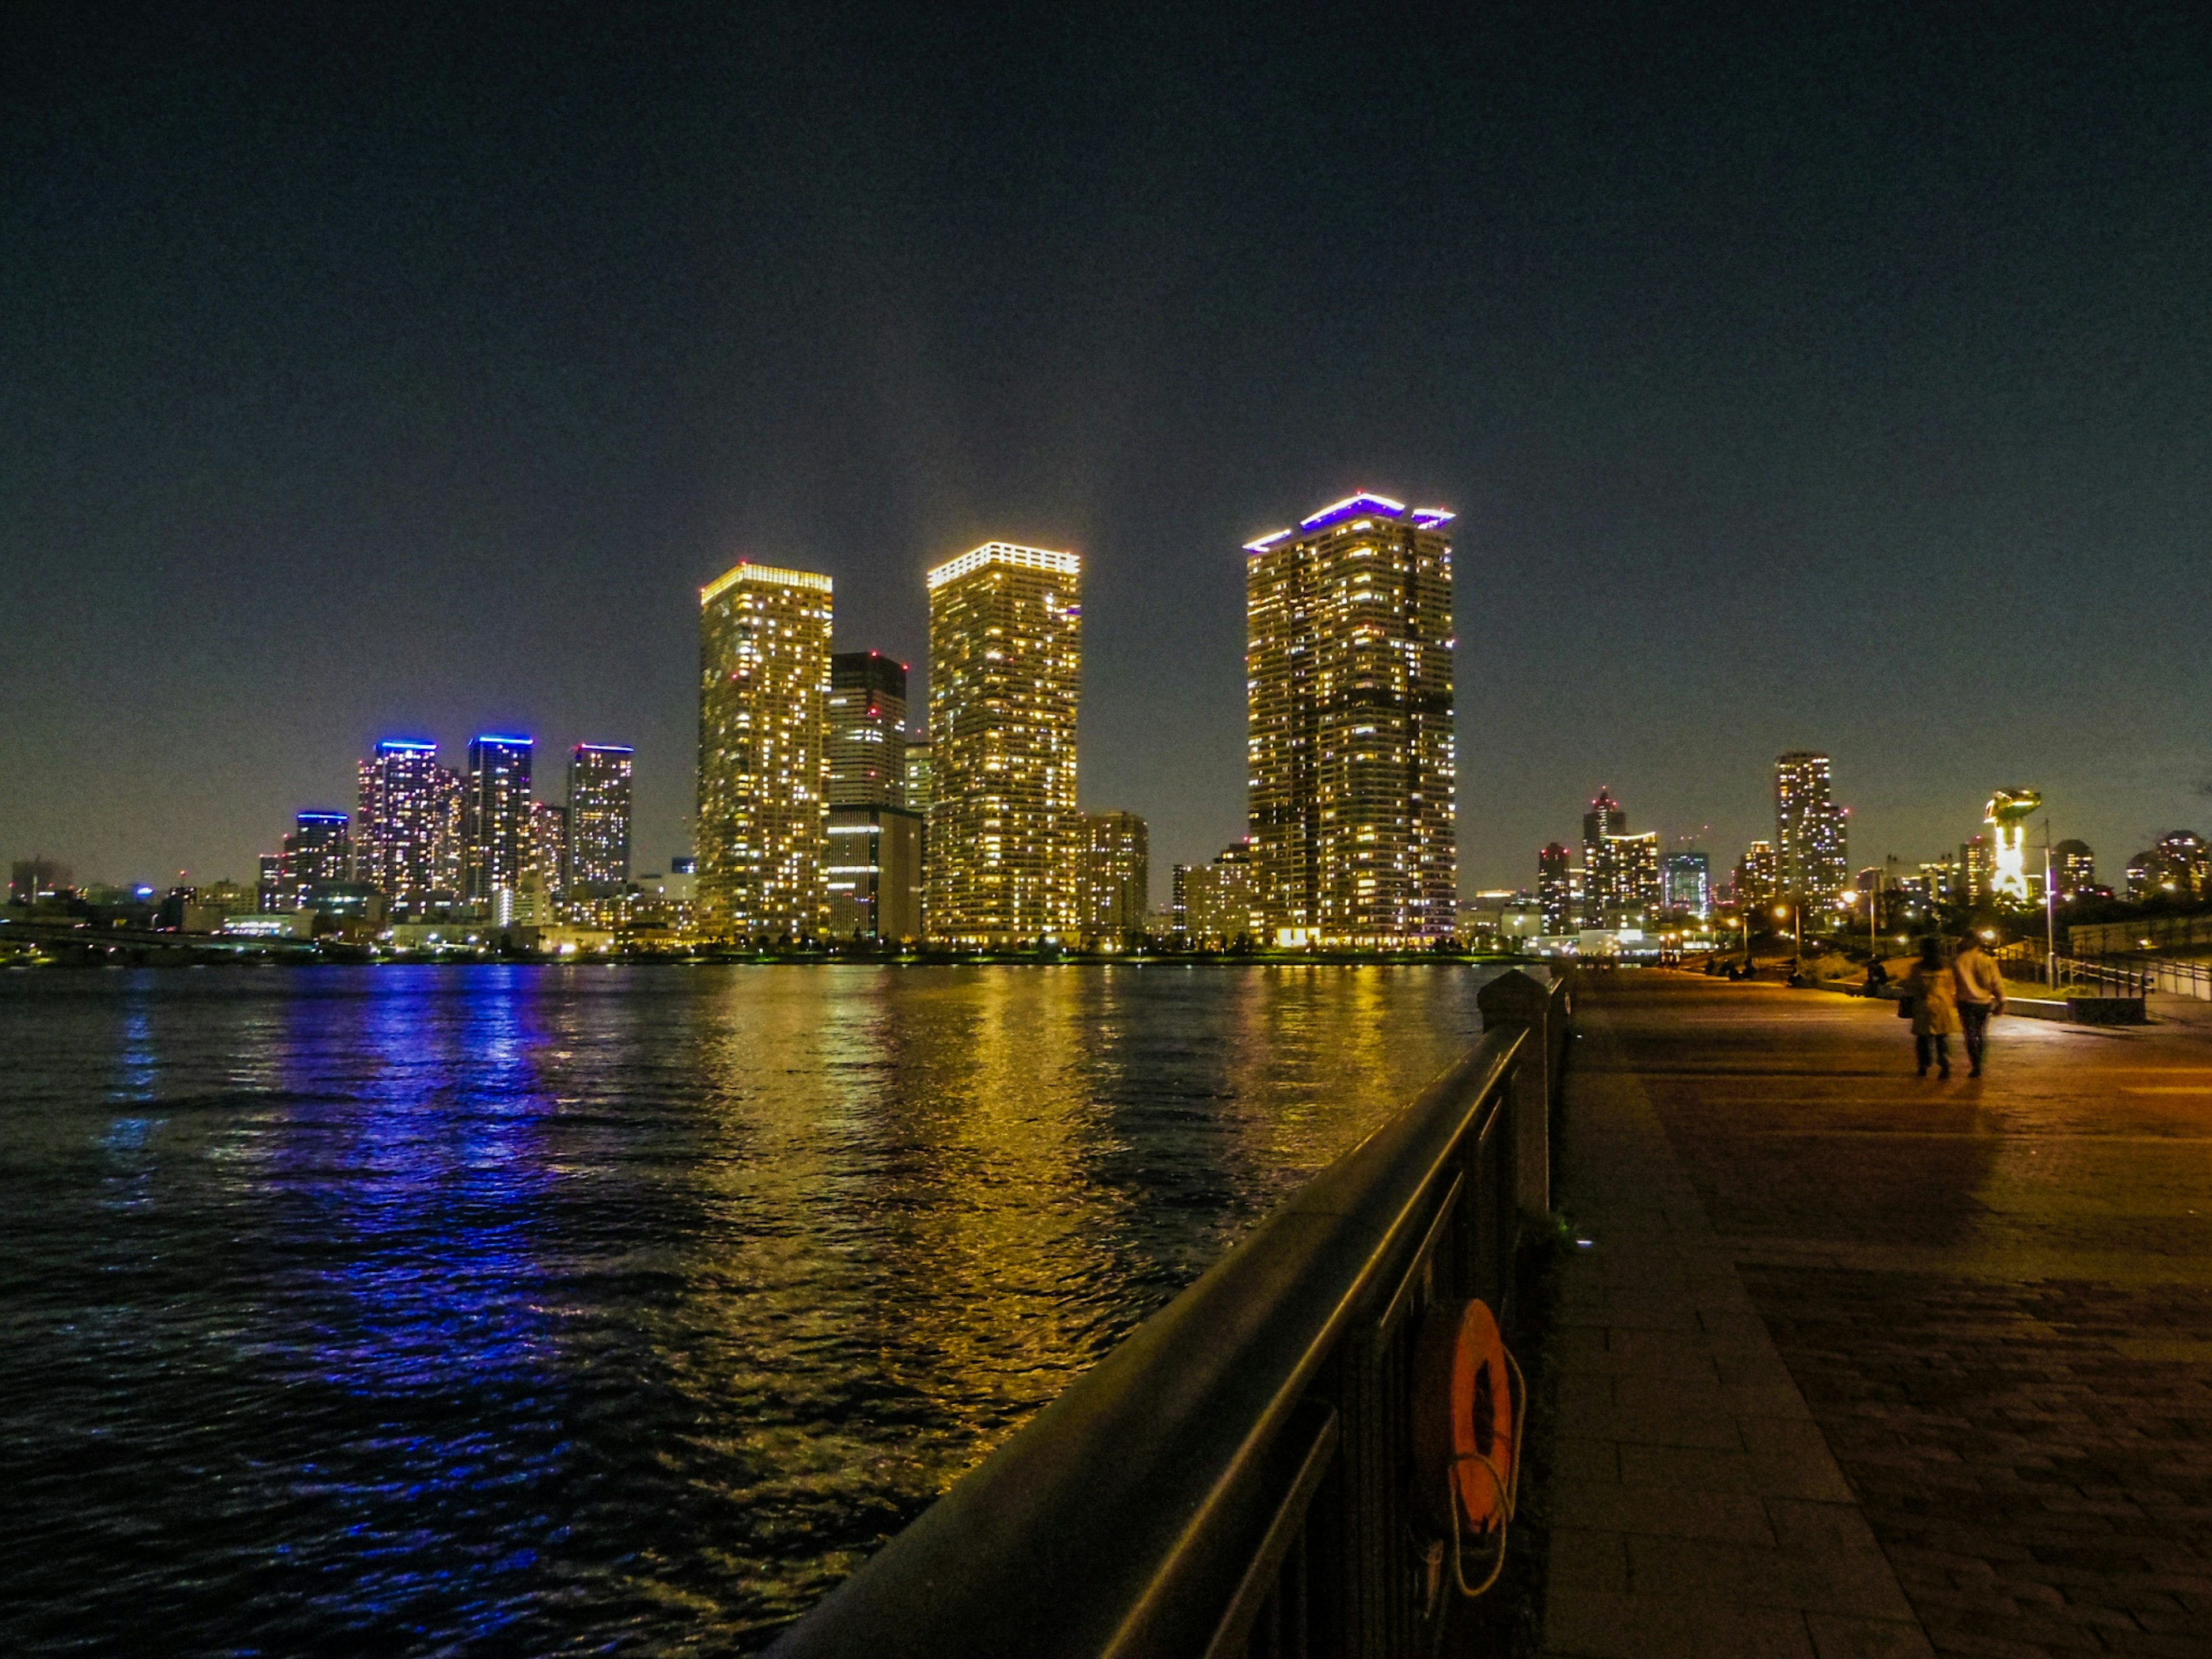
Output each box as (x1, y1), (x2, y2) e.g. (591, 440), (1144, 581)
(0, 964), (1484, 1654)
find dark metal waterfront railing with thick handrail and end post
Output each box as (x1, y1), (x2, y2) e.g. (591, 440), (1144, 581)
(772, 974), (1570, 1659)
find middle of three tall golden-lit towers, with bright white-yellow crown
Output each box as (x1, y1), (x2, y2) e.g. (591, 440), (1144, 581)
(925, 542), (1084, 945)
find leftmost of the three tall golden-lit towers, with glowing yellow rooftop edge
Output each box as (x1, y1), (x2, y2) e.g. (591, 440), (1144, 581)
(699, 564), (832, 938)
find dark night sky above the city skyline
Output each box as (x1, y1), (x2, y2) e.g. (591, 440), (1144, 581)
(0, 5), (2212, 889)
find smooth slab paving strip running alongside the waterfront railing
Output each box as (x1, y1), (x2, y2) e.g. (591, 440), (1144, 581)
(1544, 1009), (1929, 1659)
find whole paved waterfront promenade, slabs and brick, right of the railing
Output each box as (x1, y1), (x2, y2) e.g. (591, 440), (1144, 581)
(1544, 971), (2212, 1659)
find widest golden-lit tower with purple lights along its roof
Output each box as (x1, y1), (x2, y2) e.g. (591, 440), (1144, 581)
(1245, 495), (1460, 945)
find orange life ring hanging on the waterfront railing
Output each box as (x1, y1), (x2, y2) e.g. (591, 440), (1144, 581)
(1414, 1301), (1520, 1533)
